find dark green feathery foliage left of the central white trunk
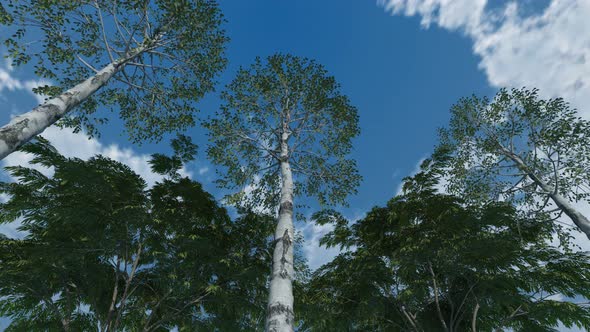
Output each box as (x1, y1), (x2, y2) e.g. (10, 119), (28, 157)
(0, 139), (274, 331)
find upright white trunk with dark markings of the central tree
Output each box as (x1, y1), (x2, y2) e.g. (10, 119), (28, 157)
(266, 134), (295, 332)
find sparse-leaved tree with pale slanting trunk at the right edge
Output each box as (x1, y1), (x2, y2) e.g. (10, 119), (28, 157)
(438, 89), (590, 237)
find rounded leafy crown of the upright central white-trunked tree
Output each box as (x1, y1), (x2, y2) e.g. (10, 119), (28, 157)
(205, 54), (360, 206)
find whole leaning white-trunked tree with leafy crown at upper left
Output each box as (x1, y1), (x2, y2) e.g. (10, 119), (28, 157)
(0, 0), (227, 159)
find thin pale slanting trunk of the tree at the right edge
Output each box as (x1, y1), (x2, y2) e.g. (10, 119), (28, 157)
(502, 148), (590, 239)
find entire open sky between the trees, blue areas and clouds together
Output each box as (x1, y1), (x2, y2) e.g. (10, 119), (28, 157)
(0, 0), (590, 330)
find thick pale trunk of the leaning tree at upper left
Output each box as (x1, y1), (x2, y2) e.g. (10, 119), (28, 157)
(0, 48), (145, 160)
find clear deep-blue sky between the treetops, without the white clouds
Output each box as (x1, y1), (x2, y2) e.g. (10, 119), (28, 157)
(0, 0), (495, 267)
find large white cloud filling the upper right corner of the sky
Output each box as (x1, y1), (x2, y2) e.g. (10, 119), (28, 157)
(379, 0), (590, 118)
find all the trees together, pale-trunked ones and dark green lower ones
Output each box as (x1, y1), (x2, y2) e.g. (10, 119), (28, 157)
(0, 0), (590, 331)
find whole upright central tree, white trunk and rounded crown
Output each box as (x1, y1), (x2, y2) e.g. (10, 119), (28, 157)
(204, 55), (360, 331)
